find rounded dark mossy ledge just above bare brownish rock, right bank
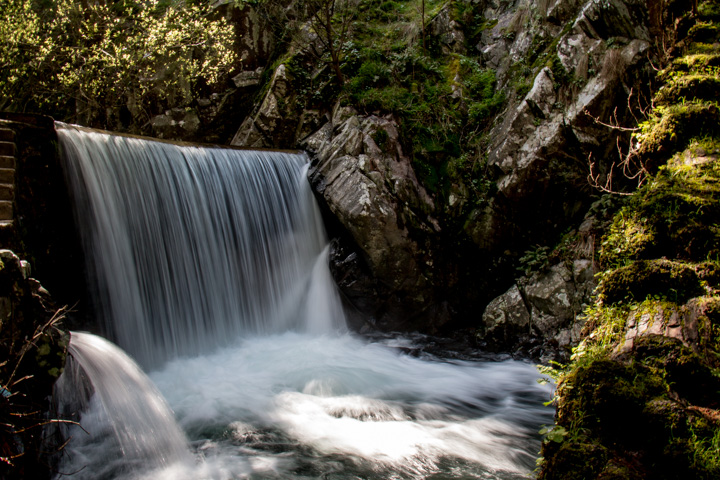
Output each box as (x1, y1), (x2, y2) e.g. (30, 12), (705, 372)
(598, 259), (704, 303)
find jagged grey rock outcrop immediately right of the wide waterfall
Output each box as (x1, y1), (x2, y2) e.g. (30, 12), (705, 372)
(304, 106), (442, 328)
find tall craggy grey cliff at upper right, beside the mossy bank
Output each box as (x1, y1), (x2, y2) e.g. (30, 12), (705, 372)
(466, 0), (650, 255)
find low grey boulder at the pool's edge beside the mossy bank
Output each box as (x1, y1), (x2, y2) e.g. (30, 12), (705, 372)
(479, 259), (595, 360)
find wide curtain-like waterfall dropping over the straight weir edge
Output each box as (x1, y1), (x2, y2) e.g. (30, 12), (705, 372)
(58, 125), (345, 367)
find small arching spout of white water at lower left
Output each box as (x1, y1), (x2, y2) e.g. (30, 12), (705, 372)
(55, 332), (193, 479)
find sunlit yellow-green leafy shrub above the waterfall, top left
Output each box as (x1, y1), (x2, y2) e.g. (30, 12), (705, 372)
(0, 0), (236, 127)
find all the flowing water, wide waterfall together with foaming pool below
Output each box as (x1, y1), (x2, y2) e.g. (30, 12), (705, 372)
(53, 125), (552, 479)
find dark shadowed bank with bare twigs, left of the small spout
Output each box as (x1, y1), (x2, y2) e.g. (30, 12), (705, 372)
(0, 250), (68, 478)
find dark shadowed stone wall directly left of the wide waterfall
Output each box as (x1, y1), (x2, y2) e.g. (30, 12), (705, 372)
(0, 112), (87, 324)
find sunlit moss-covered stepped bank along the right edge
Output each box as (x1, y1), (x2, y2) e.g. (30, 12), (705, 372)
(539, 2), (720, 479)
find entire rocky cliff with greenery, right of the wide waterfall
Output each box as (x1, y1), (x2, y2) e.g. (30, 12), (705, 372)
(228, 0), (659, 334)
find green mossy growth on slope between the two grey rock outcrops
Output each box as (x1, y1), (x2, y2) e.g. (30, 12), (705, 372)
(345, 46), (505, 198)
